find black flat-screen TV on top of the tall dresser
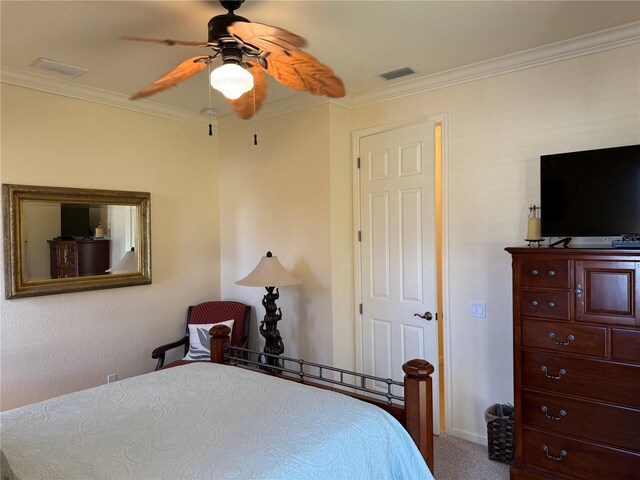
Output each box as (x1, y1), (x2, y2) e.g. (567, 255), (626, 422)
(540, 145), (640, 237)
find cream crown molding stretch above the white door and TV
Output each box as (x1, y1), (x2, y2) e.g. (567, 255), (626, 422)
(343, 22), (640, 108)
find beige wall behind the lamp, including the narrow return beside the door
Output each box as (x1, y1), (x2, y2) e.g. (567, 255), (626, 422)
(220, 104), (355, 369)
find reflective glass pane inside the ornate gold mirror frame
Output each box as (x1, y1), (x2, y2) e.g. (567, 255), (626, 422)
(22, 201), (138, 280)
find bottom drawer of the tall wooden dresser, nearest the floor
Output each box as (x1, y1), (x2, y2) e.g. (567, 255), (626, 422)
(522, 428), (640, 480)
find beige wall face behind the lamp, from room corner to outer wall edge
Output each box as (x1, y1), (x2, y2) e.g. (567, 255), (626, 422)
(220, 104), (332, 363)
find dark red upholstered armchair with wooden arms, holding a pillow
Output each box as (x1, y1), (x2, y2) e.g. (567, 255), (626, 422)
(151, 301), (251, 370)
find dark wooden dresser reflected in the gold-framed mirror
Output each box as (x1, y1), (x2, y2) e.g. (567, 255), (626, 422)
(48, 238), (109, 278)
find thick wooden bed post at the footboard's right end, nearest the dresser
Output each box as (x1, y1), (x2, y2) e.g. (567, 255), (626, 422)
(402, 359), (434, 473)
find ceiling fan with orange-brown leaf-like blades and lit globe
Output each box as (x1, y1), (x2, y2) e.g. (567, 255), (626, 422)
(123, 0), (345, 119)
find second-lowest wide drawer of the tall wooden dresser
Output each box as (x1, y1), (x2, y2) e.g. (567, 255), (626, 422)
(521, 390), (640, 452)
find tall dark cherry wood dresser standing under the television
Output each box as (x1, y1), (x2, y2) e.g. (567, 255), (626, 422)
(506, 247), (640, 480)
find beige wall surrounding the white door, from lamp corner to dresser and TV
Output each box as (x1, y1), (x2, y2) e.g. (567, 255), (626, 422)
(220, 45), (640, 442)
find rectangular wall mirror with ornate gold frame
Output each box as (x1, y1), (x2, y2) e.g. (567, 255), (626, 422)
(2, 184), (151, 299)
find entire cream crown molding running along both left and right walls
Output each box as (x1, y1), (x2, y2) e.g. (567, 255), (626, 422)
(0, 22), (640, 127)
